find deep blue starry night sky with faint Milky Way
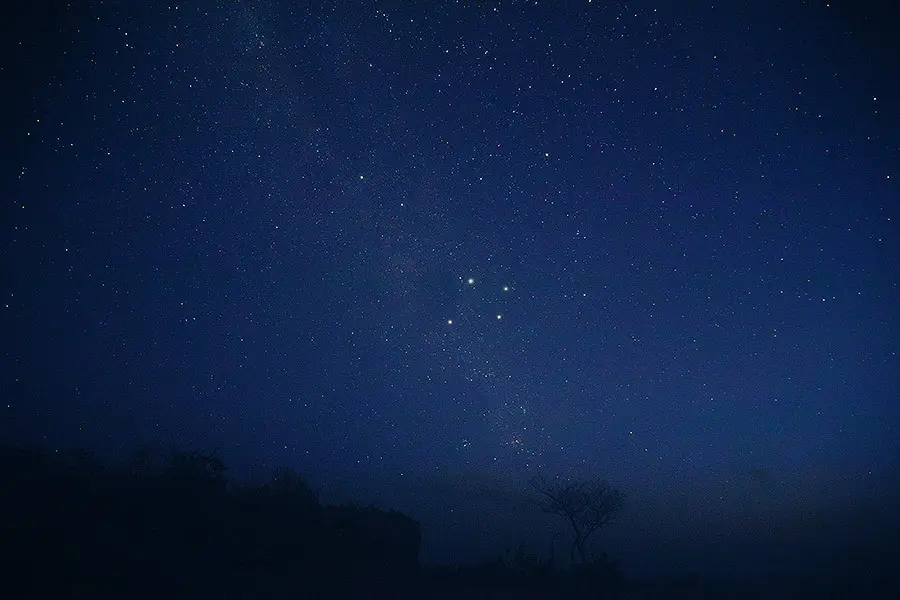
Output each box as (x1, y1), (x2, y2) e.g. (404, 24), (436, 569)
(0, 0), (900, 571)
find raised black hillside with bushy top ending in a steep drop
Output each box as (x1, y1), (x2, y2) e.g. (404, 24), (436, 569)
(0, 447), (420, 598)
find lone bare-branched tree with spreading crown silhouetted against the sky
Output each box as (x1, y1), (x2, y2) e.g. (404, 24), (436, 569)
(531, 475), (625, 566)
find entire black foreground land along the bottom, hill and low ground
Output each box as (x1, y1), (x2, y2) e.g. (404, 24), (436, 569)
(0, 446), (900, 600)
